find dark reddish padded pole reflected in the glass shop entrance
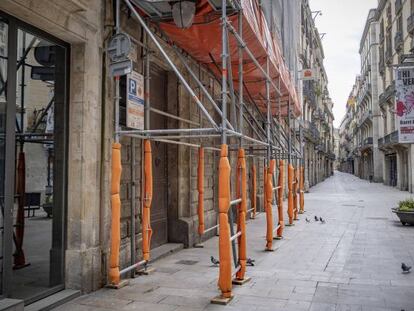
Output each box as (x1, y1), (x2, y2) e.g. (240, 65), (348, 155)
(13, 152), (26, 269)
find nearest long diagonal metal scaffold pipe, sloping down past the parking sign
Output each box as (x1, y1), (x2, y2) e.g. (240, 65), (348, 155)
(124, 0), (218, 129)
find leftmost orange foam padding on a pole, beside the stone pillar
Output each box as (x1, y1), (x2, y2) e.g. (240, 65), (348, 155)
(109, 143), (122, 285)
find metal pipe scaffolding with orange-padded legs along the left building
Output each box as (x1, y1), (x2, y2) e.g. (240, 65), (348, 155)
(110, 0), (303, 302)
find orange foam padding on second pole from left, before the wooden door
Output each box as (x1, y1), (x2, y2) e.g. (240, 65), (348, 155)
(142, 140), (152, 261)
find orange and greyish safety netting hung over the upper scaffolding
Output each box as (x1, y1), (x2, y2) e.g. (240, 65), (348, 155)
(146, 0), (301, 116)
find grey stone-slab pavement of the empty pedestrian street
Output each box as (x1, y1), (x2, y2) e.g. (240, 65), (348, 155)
(58, 172), (414, 311)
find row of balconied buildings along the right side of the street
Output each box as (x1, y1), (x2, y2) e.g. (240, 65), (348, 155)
(340, 0), (414, 192)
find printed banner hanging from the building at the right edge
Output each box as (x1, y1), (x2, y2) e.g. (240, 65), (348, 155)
(395, 67), (414, 144)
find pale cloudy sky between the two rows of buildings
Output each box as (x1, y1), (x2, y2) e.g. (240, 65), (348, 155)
(309, 0), (377, 127)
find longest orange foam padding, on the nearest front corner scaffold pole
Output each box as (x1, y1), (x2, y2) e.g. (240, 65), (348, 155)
(218, 144), (232, 298)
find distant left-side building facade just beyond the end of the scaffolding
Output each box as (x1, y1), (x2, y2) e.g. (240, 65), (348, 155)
(300, 0), (335, 189)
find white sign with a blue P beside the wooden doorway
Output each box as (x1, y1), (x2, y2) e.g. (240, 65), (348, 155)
(126, 71), (144, 130)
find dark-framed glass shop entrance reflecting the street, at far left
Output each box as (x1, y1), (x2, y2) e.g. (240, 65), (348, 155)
(0, 11), (69, 304)
